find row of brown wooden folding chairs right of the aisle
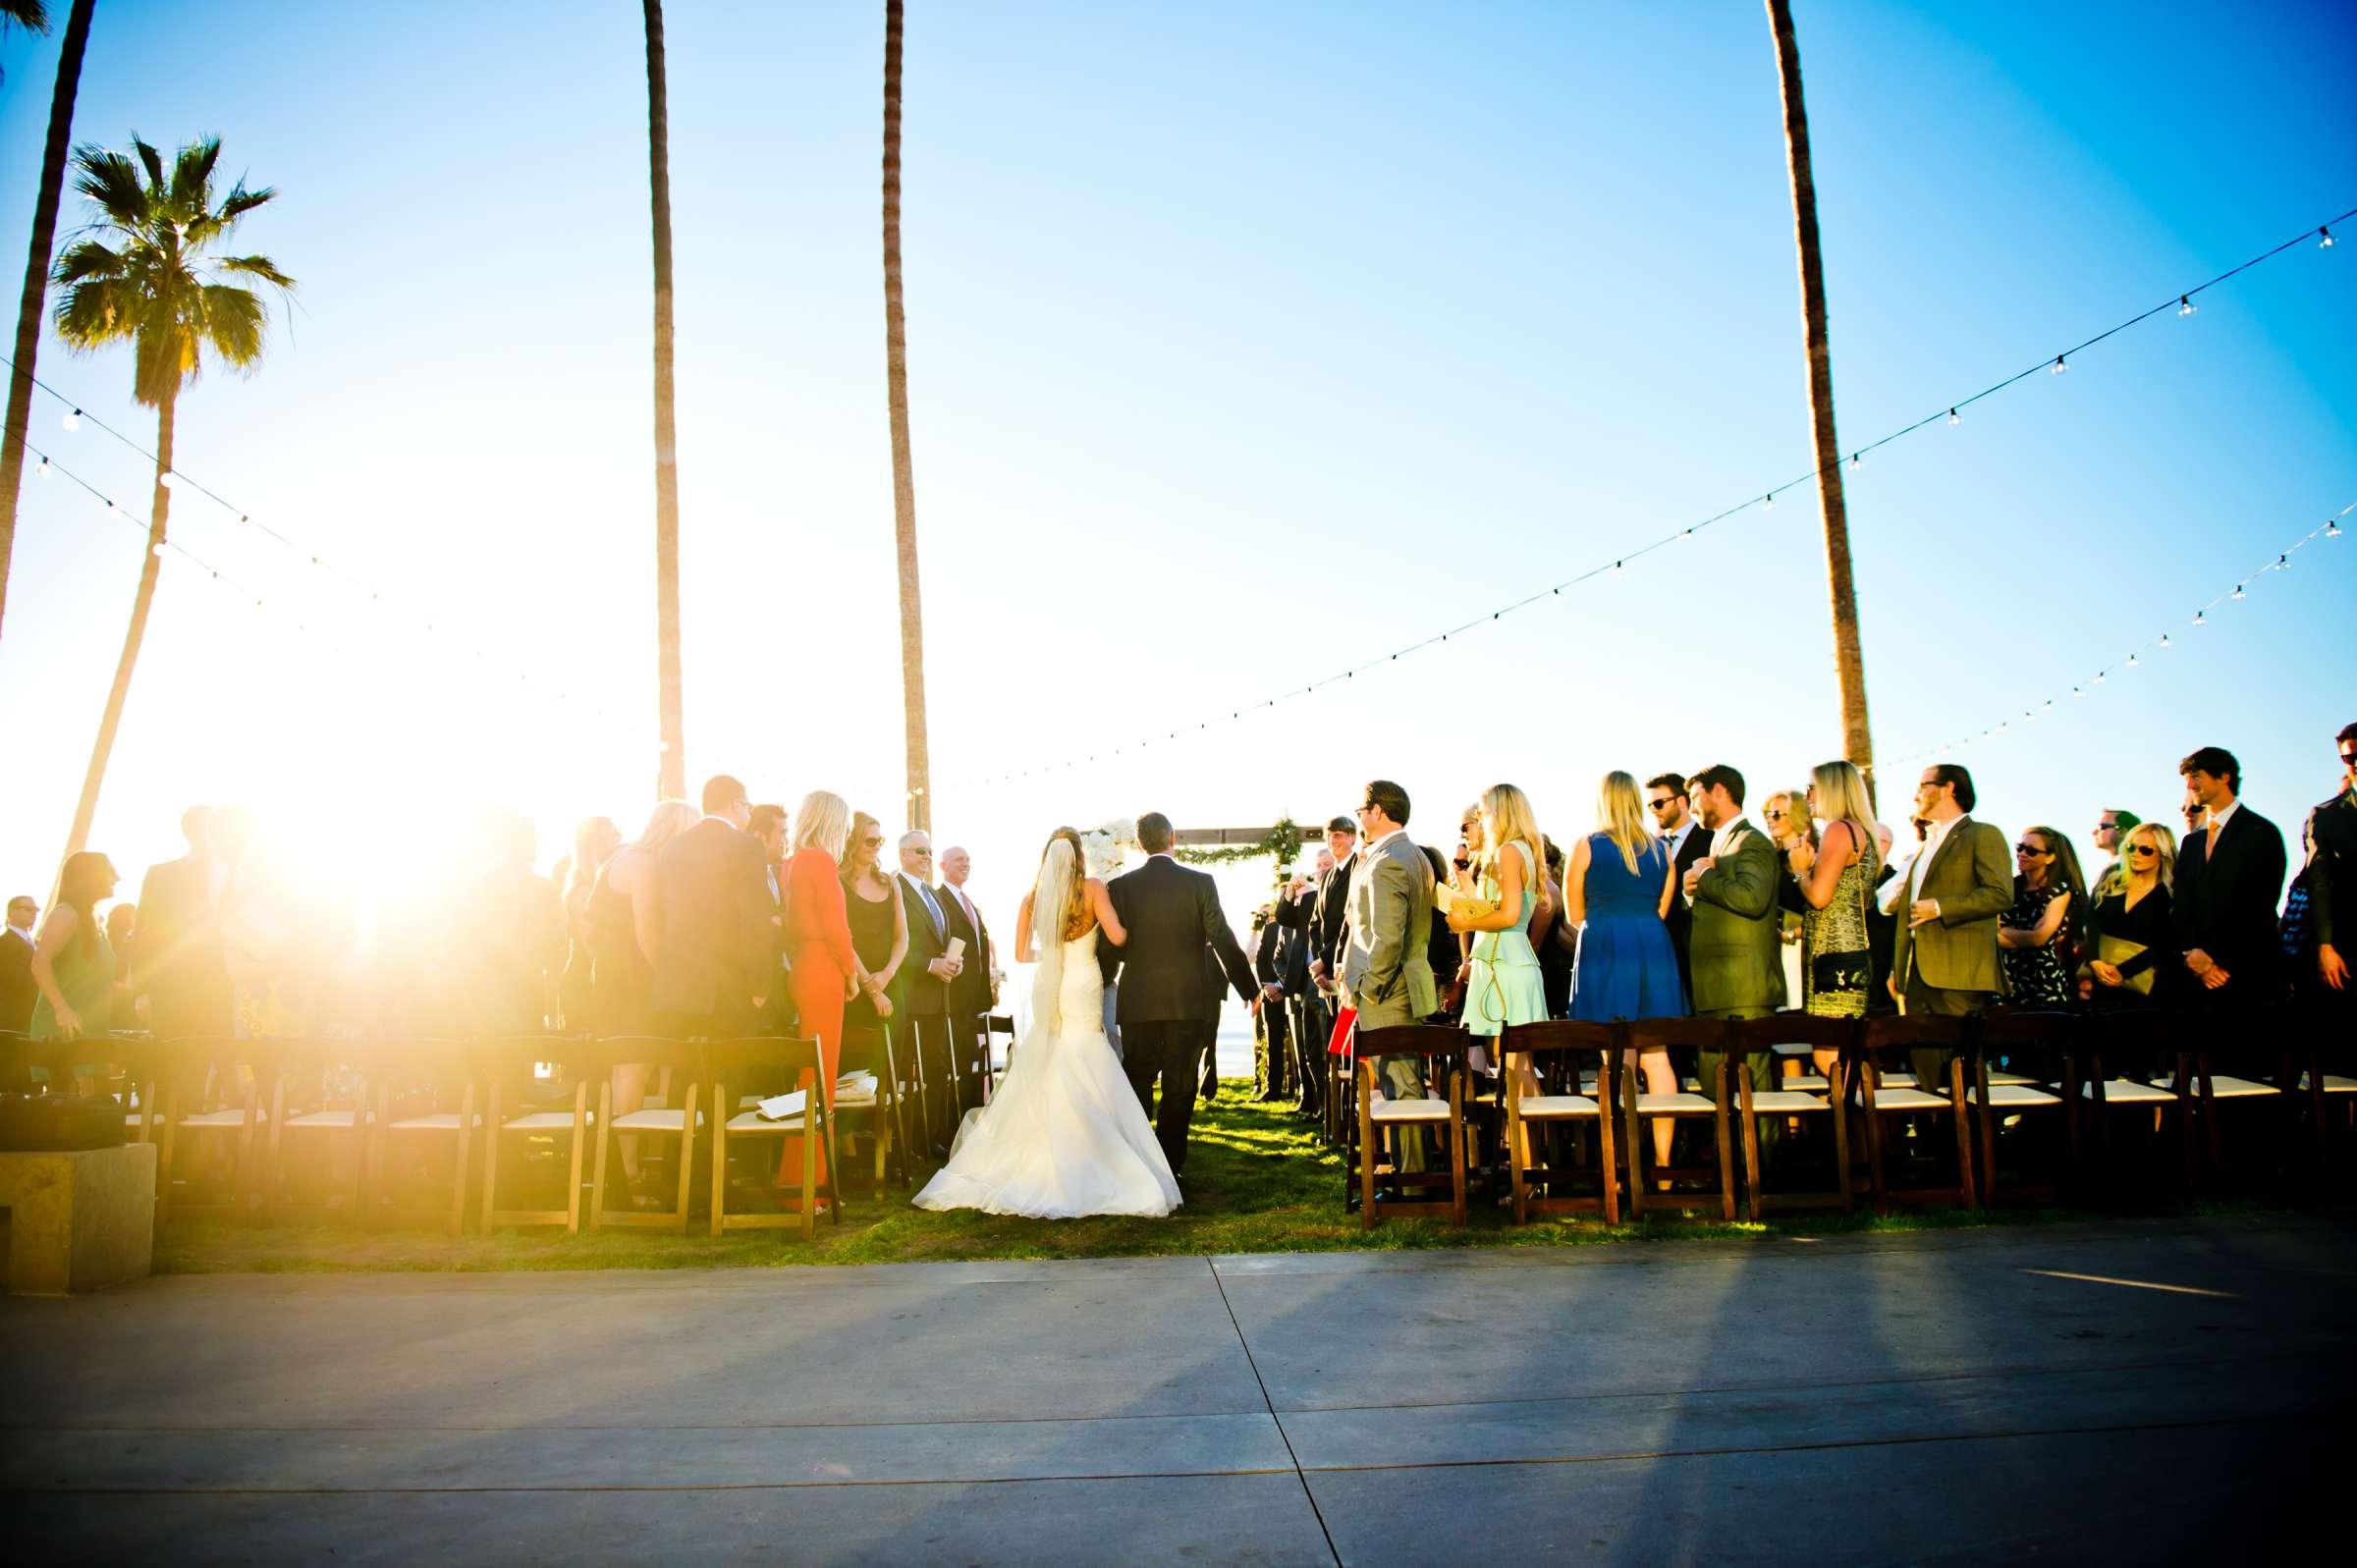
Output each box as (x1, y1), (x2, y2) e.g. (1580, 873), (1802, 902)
(1334, 1009), (2357, 1226)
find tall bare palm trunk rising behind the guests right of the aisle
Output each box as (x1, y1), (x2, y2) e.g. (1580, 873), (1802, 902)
(1768, 0), (1874, 785)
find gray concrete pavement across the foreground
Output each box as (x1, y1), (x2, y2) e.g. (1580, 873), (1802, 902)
(0, 1217), (2357, 1563)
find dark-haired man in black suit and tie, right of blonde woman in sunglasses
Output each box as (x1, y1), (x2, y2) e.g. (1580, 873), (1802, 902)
(2168, 745), (2284, 1037)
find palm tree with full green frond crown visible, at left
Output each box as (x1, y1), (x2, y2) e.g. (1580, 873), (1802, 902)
(52, 136), (295, 856)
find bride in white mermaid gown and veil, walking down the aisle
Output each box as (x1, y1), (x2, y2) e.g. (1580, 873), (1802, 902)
(917, 828), (1178, 1219)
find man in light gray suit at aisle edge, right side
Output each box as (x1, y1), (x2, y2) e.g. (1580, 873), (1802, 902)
(1342, 778), (1440, 1172)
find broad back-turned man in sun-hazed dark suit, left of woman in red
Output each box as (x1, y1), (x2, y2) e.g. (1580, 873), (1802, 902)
(653, 774), (778, 1040)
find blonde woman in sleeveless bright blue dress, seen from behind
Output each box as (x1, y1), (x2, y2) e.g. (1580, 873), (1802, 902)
(1562, 771), (1685, 1164)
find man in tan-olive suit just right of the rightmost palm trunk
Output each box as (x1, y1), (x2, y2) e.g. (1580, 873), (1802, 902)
(1891, 762), (2013, 1094)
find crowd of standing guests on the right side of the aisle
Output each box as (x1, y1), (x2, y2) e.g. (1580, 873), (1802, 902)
(1256, 724), (2357, 1158)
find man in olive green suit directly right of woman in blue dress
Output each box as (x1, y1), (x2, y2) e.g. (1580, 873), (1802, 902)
(1685, 764), (1784, 1117)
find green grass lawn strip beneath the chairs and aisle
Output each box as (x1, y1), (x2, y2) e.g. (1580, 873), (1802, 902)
(155, 1082), (2187, 1273)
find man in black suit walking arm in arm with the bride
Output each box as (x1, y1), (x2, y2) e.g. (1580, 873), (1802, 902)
(1098, 811), (1259, 1176)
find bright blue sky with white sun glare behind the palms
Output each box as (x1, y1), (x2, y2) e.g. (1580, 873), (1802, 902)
(0, 0), (2357, 917)
